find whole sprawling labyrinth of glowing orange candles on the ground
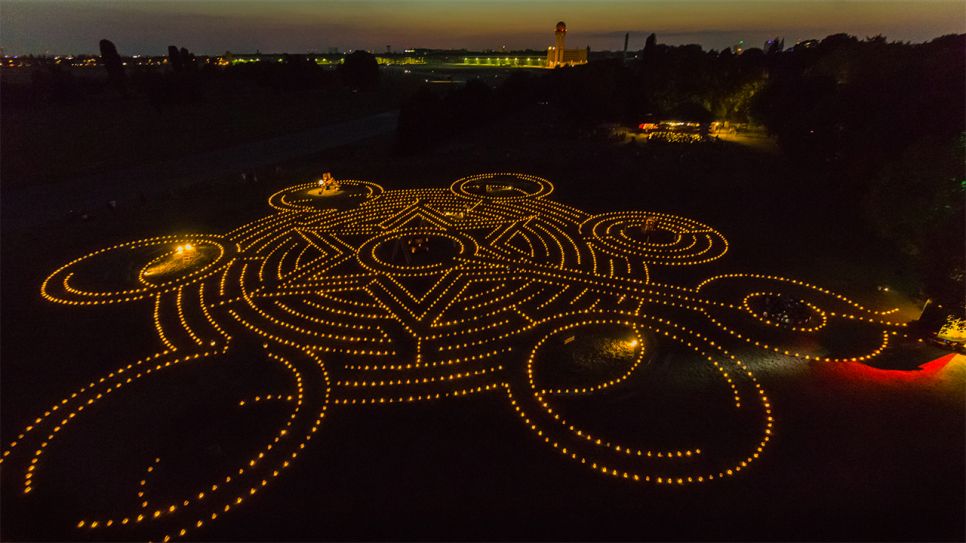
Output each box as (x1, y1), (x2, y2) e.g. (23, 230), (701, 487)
(2, 173), (903, 541)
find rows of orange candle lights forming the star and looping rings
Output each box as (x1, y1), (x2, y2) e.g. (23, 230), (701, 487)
(0, 173), (904, 541)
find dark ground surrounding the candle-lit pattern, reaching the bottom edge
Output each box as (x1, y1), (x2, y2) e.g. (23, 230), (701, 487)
(0, 108), (966, 541)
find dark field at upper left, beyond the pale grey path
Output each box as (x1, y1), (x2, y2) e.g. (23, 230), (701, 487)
(0, 69), (414, 187)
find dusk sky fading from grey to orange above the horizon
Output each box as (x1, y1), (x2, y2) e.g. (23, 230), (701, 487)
(0, 0), (966, 55)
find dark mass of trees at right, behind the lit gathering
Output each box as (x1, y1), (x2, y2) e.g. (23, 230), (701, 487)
(398, 34), (966, 305)
